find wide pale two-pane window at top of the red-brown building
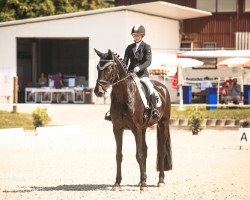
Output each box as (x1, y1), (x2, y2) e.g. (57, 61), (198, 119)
(196, 0), (236, 12)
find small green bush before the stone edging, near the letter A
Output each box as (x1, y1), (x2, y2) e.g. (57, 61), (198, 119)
(189, 108), (204, 135)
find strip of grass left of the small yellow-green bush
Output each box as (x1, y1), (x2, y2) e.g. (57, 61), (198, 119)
(0, 111), (35, 130)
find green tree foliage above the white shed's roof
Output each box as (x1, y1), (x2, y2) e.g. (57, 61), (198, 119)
(0, 0), (111, 22)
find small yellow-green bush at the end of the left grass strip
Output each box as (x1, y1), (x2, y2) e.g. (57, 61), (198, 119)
(32, 108), (51, 128)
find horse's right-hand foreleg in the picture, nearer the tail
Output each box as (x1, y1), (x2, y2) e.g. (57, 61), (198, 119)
(134, 131), (147, 190)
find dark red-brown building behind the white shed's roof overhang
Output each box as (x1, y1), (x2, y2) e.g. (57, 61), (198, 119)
(115, 0), (250, 50)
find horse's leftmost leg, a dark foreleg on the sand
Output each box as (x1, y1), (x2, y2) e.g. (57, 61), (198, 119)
(112, 127), (123, 191)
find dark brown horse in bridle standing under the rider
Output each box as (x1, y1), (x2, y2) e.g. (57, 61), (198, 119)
(94, 49), (172, 191)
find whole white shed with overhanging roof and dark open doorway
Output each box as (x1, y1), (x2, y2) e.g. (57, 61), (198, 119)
(0, 2), (211, 103)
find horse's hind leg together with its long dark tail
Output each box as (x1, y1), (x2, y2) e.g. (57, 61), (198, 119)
(157, 120), (172, 187)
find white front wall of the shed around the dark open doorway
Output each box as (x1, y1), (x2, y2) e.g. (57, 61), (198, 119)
(0, 12), (128, 86)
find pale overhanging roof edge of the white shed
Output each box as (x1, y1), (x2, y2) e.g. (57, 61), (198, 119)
(0, 1), (211, 27)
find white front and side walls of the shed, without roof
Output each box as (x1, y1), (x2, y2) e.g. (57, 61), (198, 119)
(0, 11), (179, 102)
